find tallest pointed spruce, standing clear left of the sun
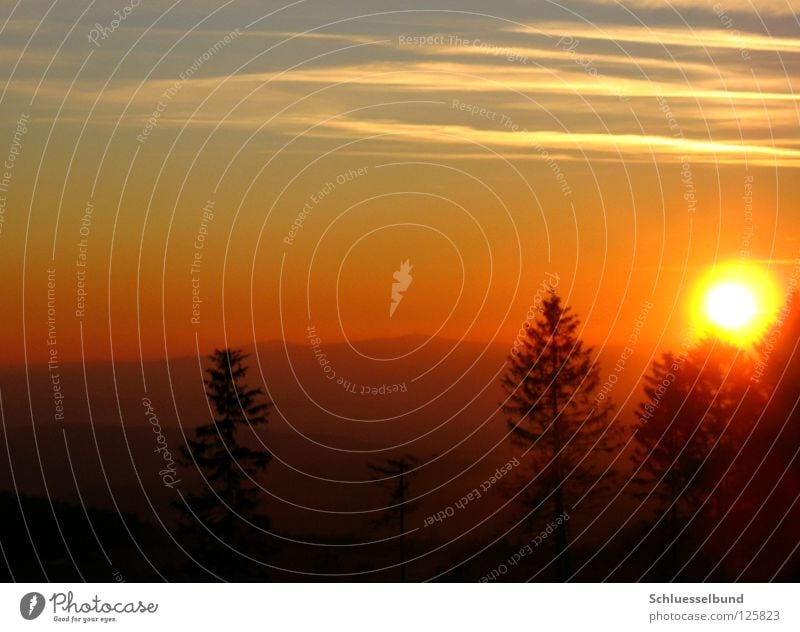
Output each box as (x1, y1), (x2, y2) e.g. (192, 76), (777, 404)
(502, 291), (620, 581)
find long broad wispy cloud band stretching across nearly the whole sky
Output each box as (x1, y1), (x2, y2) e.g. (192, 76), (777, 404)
(10, 54), (800, 161)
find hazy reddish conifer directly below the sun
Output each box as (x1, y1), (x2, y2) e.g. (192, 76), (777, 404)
(633, 339), (765, 576)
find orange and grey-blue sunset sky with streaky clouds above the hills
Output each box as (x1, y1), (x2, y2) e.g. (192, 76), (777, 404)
(0, 0), (800, 363)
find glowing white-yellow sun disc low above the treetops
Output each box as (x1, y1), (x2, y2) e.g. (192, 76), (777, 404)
(693, 262), (780, 346)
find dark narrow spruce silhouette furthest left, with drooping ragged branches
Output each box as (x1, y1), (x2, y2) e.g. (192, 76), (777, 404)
(177, 349), (272, 580)
